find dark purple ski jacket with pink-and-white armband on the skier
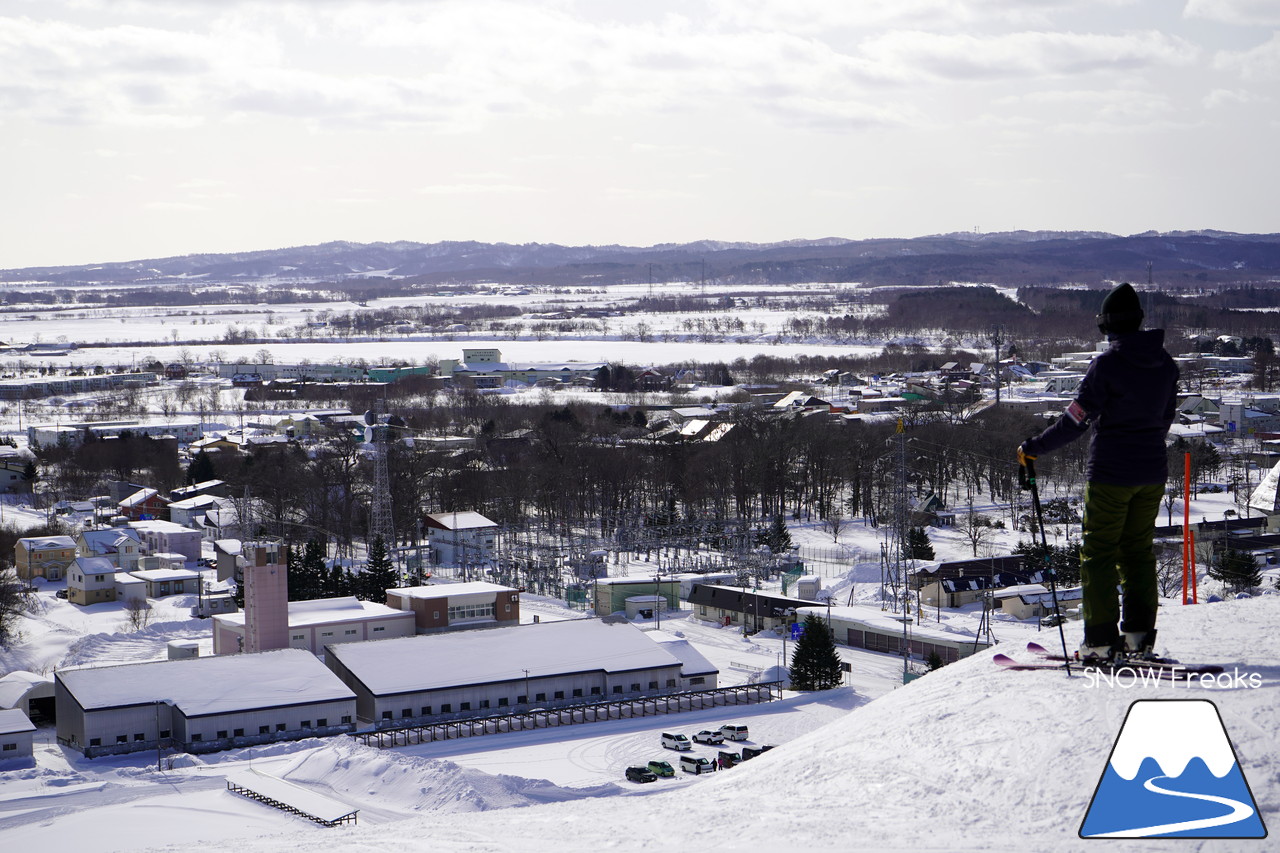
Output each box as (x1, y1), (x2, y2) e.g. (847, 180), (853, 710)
(1023, 329), (1178, 485)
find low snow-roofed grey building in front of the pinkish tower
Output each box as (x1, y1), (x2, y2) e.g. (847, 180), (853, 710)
(54, 648), (356, 758)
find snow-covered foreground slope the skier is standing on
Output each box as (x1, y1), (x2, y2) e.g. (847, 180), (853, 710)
(160, 596), (1280, 853)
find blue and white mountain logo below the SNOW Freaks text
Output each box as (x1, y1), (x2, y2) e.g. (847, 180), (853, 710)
(1080, 699), (1267, 838)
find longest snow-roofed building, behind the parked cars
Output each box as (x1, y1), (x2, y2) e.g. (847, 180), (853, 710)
(325, 619), (719, 727)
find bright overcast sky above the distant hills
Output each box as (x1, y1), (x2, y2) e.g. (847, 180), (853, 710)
(0, 0), (1280, 268)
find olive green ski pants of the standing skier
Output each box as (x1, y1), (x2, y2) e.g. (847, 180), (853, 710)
(1080, 482), (1165, 646)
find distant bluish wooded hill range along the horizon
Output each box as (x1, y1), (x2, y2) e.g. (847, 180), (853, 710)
(0, 231), (1280, 288)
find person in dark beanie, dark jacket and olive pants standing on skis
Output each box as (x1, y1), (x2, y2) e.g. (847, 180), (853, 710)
(1018, 283), (1178, 661)
